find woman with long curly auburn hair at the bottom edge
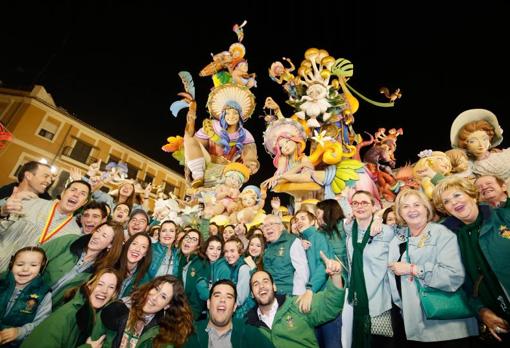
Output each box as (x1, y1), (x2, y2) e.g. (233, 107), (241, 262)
(87, 275), (193, 348)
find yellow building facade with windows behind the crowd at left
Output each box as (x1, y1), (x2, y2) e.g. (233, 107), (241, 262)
(0, 86), (186, 206)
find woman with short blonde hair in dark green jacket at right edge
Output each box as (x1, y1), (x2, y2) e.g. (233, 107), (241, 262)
(433, 177), (510, 343)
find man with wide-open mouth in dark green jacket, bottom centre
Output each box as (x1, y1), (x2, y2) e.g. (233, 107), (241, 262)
(186, 279), (273, 348)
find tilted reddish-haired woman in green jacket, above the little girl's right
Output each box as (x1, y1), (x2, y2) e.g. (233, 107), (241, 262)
(42, 222), (124, 310)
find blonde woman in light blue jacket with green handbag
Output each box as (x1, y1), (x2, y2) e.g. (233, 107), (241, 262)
(389, 189), (478, 347)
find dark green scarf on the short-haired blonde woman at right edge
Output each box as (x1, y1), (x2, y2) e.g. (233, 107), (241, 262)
(457, 212), (510, 320)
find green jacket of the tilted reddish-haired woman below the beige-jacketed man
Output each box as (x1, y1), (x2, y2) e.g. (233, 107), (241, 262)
(42, 234), (93, 310)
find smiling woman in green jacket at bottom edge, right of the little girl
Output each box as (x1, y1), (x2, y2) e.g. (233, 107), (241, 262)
(21, 267), (120, 348)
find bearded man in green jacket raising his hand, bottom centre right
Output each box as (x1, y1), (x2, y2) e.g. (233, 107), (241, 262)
(246, 252), (345, 348)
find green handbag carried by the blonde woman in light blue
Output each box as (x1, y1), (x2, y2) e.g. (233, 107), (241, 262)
(406, 238), (474, 320)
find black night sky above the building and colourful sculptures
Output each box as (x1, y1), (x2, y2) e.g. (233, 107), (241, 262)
(0, 0), (510, 188)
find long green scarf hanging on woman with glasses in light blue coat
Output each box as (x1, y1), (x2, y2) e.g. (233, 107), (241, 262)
(348, 220), (372, 348)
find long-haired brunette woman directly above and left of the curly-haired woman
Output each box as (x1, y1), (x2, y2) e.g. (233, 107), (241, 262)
(117, 232), (152, 298)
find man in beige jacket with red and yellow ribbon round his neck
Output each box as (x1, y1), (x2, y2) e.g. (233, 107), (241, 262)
(0, 180), (90, 272)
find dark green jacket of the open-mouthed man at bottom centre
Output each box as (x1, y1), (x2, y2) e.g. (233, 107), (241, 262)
(184, 319), (274, 348)
